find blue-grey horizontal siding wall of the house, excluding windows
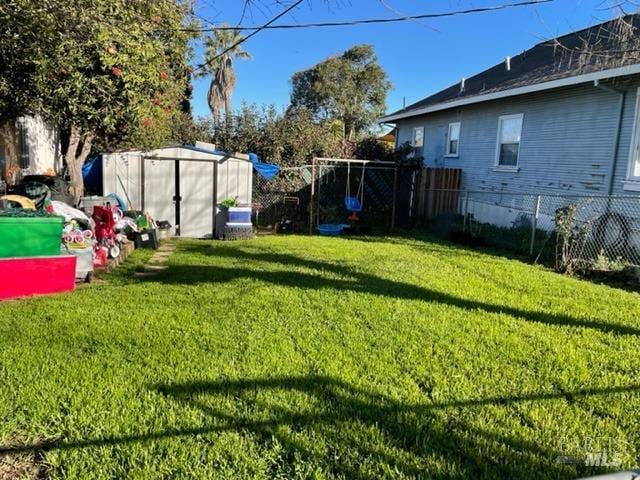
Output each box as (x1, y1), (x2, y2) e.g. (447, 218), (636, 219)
(397, 80), (640, 195)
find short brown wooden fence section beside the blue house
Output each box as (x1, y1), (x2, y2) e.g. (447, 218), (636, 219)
(417, 168), (462, 219)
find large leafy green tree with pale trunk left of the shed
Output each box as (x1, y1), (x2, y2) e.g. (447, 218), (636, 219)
(0, 0), (190, 198)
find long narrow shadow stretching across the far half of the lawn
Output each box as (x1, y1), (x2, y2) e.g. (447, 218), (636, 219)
(156, 243), (640, 335)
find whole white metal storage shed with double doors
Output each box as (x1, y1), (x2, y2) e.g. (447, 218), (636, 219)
(102, 146), (253, 238)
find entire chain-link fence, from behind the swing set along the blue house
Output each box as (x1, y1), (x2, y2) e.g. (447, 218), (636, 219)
(253, 171), (640, 271)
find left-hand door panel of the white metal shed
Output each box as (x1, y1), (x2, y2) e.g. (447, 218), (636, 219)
(144, 159), (176, 235)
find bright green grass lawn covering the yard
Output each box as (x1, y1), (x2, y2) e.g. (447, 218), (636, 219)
(0, 236), (640, 479)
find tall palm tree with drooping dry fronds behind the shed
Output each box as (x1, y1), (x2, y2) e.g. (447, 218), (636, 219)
(202, 24), (251, 126)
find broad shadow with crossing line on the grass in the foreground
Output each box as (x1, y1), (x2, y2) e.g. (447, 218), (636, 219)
(0, 376), (640, 478)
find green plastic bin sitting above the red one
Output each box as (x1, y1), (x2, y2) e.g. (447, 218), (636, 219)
(0, 217), (64, 258)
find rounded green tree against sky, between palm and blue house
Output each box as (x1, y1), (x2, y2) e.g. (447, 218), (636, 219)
(291, 45), (391, 141)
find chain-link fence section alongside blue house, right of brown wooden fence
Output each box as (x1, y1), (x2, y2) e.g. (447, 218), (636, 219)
(424, 190), (640, 270)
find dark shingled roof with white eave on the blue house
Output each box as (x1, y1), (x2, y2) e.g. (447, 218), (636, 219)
(380, 13), (640, 122)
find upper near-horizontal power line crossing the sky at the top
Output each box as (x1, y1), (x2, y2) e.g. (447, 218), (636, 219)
(184, 0), (553, 32)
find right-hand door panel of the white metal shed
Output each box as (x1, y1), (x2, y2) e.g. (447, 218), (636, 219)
(180, 161), (214, 238)
